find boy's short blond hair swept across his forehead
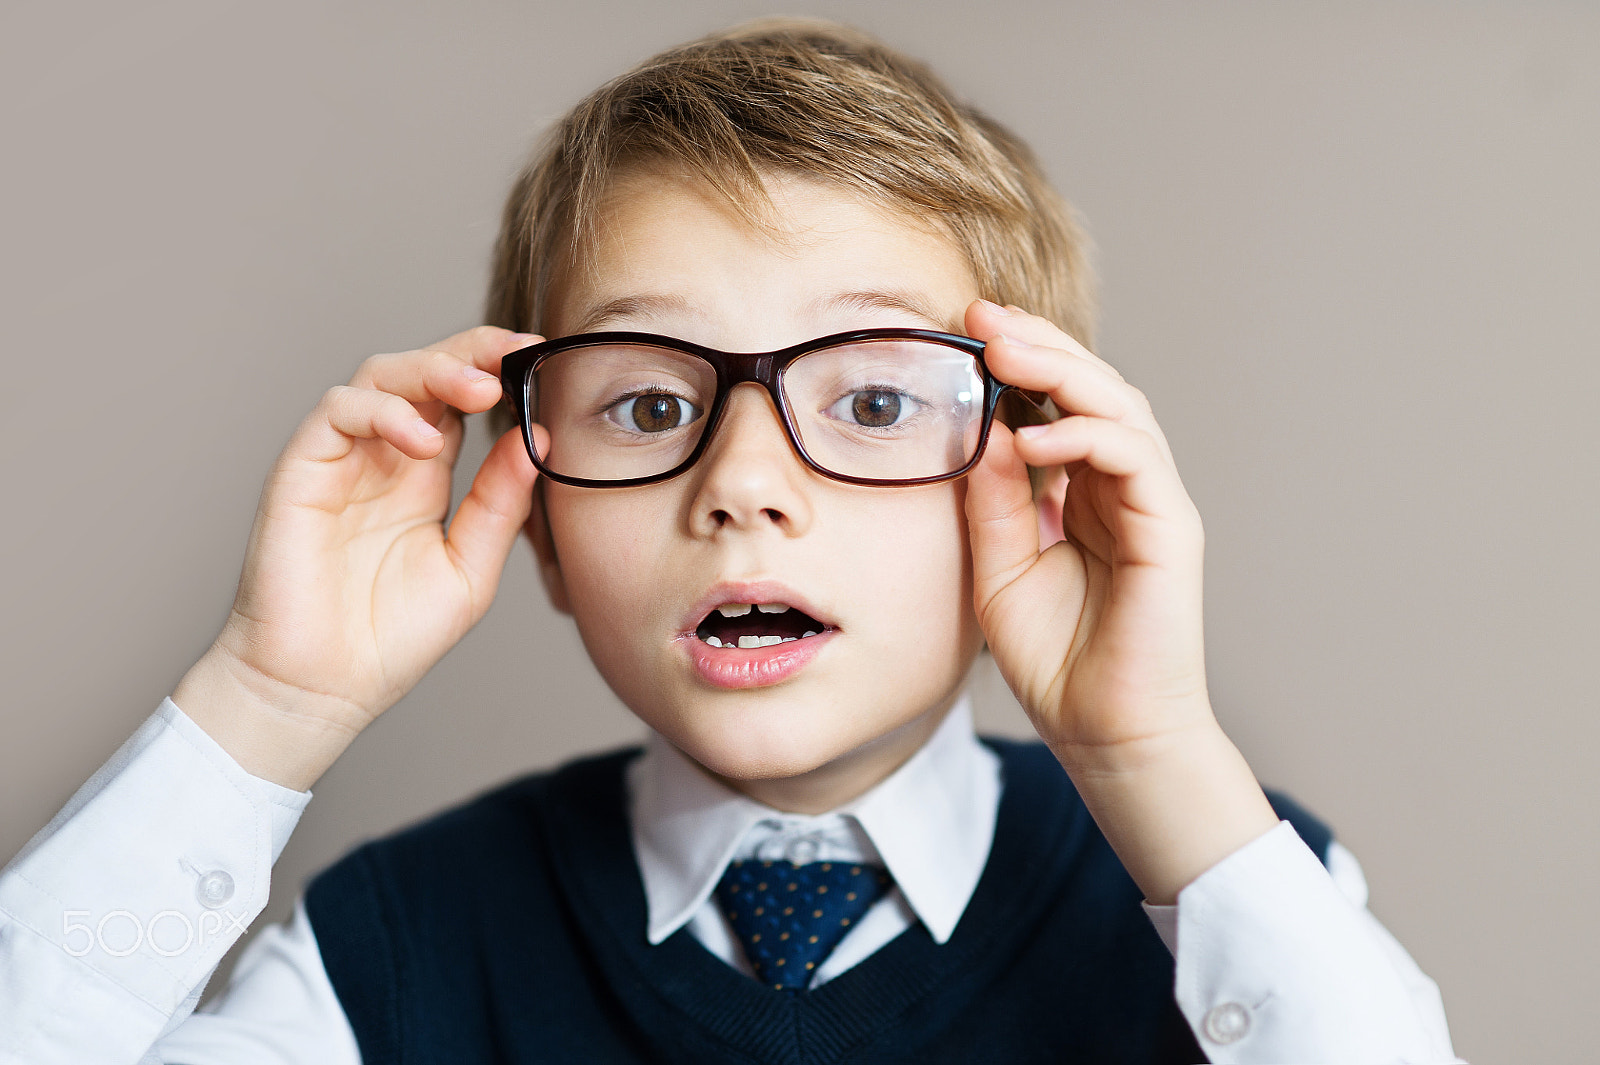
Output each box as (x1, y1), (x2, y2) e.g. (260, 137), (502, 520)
(485, 18), (1094, 433)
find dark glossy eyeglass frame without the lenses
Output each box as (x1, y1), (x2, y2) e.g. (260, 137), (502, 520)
(501, 329), (1043, 488)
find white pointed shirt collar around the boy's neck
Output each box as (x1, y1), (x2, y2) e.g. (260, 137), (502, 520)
(627, 694), (1000, 943)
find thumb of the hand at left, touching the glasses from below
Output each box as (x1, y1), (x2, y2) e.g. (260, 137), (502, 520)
(445, 425), (550, 591)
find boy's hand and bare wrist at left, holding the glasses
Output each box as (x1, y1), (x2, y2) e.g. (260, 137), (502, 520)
(173, 326), (549, 792)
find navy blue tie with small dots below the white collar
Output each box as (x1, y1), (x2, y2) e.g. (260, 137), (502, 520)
(717, 862), (890, 991)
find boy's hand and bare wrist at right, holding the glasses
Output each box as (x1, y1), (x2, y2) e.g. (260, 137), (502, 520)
(966, 301), (1277, 902)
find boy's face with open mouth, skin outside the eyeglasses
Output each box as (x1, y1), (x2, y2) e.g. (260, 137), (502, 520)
(534, 163), (982, 809)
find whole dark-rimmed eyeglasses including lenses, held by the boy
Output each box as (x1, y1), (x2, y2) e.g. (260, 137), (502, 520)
(501, 329), (1037, 488)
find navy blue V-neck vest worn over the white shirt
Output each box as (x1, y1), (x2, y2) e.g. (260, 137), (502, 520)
(306, 740), (1331, 1065)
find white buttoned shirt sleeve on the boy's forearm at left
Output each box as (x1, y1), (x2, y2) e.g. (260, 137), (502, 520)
(0, 699), (310, 1062)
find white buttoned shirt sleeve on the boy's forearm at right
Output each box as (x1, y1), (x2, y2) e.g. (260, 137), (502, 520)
(1146, 820), (1453, 1065)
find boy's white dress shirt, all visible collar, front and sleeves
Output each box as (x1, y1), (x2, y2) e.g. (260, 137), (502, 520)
(0, 699), (1458, 1065)
